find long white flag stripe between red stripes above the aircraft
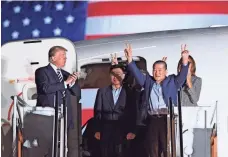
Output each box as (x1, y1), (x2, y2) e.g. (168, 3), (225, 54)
(86, 14), (228, 35)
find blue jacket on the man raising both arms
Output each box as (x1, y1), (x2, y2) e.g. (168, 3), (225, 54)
(128, 61), (189, 125)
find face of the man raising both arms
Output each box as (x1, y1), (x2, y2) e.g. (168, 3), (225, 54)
(153, 63), (167, 82)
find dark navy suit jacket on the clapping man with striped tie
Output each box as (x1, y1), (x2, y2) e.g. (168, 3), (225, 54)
(35, 64), (81, 127)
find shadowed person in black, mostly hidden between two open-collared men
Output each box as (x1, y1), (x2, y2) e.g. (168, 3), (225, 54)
(111, 53), (145, 157)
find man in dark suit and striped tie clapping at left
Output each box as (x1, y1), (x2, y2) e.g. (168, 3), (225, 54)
(25, 46), (80, 157)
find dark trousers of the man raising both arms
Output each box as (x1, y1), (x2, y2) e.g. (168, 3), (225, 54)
(144, 115), (167, 157)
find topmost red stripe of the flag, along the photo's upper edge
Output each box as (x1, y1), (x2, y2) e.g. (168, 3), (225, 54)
(88, 1), (228, 17)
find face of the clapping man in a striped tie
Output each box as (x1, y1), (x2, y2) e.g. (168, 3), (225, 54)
(52, 50), (67, 68)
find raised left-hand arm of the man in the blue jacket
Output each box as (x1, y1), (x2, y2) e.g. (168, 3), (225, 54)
(124, 44), (146, 87)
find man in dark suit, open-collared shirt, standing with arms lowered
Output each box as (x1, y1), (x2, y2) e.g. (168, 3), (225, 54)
(94, 65), (135, 157)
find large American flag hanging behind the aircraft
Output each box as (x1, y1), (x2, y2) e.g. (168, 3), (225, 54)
(1, 1), (228, 44)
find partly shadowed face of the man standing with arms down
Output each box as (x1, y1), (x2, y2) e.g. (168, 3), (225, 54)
(110, 68), (124, 85)
